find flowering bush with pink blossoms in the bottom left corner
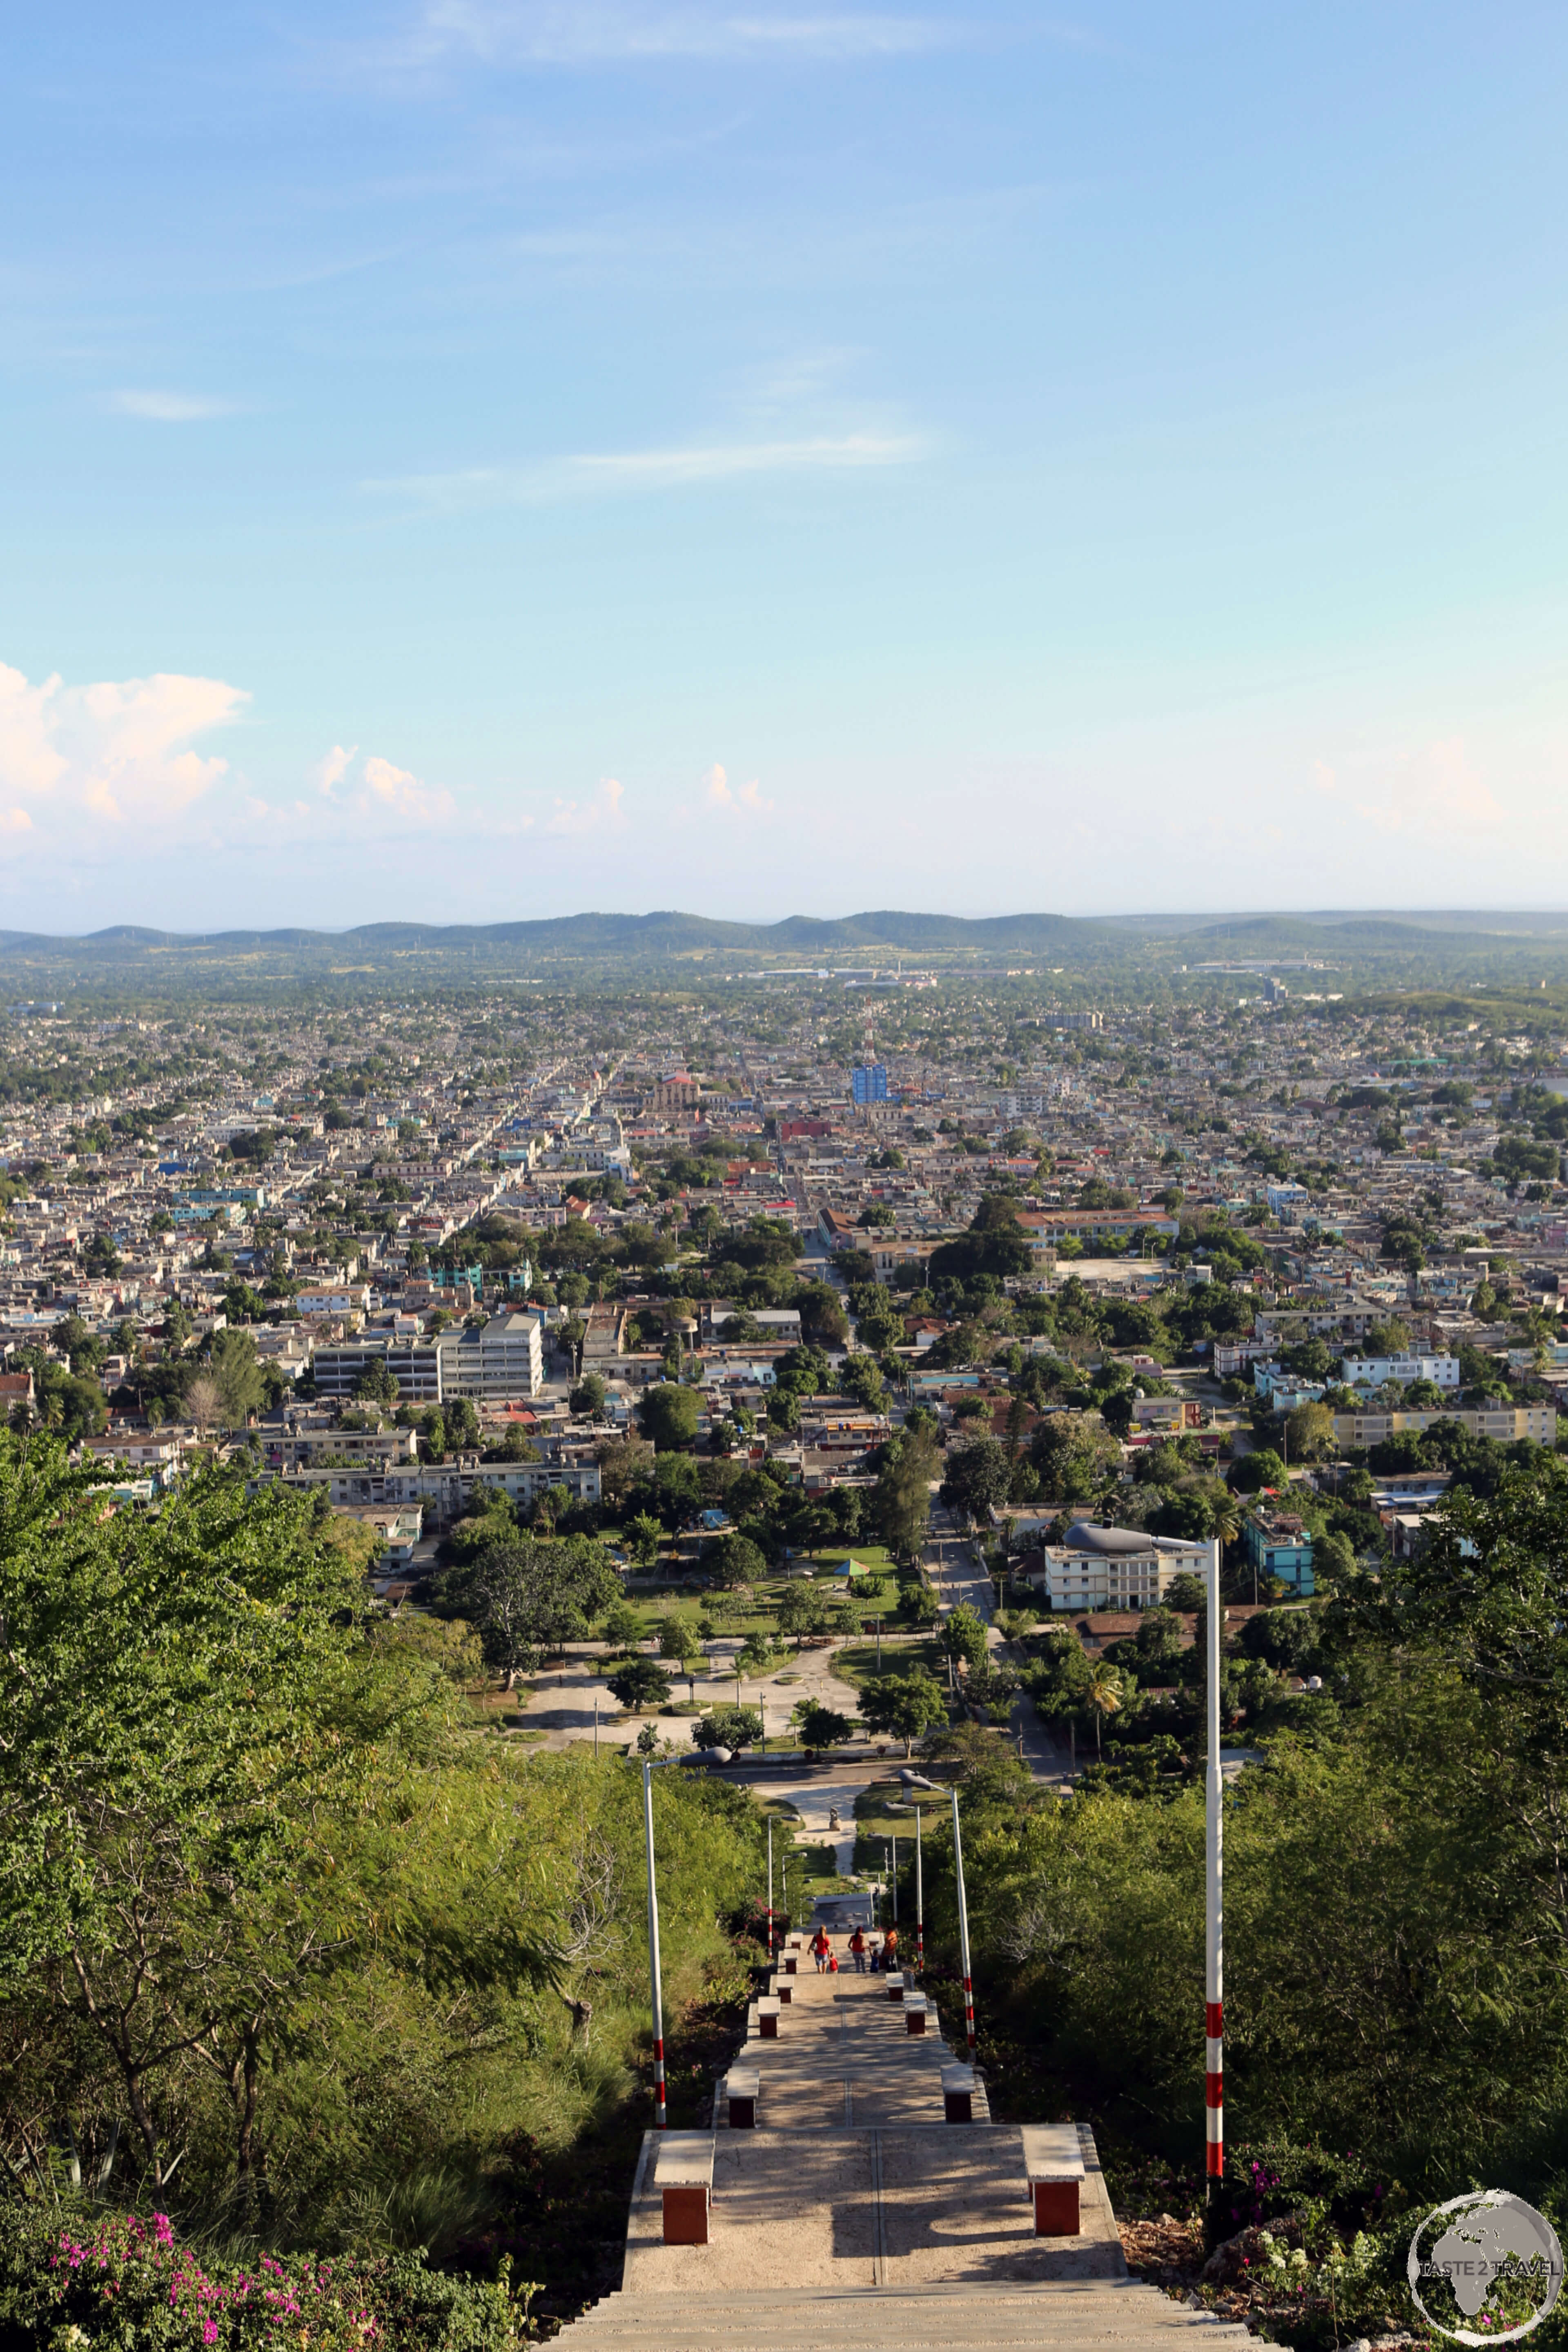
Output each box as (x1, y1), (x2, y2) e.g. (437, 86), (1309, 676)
(0, 2206), (534, 2352)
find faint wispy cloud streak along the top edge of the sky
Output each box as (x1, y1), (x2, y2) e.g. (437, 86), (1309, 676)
(404, 0), (962, 66)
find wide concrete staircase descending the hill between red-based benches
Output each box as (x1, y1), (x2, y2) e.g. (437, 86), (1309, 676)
(571, 1957), (1251, 2352)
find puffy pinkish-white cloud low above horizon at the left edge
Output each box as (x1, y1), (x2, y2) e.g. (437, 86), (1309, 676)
(0, 663), (249, 833)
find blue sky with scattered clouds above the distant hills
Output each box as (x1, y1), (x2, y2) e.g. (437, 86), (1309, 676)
(0, 0), (1568, 929)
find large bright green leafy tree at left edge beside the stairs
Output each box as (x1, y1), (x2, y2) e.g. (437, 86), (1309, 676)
(0, 1437), (548, 2190)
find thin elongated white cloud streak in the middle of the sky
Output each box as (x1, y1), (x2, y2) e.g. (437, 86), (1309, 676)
(374, 433), (929, 510)
